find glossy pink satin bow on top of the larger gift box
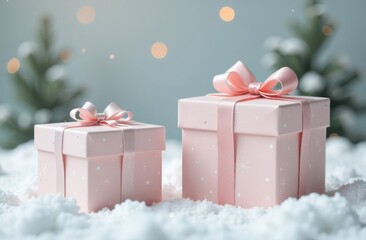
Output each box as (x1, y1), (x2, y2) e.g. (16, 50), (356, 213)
(213, 61), (298, 97)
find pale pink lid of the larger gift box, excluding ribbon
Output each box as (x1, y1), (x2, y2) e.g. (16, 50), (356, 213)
(178, 95), (330, 136)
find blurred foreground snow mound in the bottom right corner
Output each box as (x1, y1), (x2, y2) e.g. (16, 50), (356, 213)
(253, 194), (362, 239)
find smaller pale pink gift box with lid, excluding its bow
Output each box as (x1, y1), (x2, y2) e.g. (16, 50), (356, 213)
(34, 122), (165, 212)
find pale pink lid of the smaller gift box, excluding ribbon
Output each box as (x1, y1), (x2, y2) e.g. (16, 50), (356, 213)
(34, 122), (165, 158)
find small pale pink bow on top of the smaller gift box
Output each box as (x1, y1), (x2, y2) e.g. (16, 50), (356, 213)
(70, 102), (133, 125)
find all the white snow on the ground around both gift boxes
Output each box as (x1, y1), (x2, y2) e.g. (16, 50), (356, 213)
(0, 138), (366, 240)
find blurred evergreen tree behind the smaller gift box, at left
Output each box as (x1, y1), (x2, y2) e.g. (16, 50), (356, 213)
(0, 17), (83, 149)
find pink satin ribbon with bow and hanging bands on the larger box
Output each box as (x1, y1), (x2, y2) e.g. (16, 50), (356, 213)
(213, 61), (310, 204)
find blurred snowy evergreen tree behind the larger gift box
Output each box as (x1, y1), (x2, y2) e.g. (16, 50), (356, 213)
(263, 0), (366, 142)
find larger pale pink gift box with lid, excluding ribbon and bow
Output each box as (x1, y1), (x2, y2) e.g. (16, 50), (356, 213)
(178, 96), (329, 207)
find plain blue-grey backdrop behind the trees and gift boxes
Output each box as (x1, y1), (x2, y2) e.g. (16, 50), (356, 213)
(0, 0), (366, 139)
